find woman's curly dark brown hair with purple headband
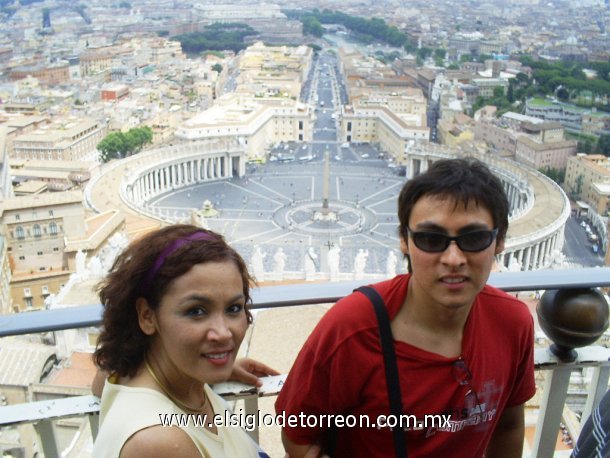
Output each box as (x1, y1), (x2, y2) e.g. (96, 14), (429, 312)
(93, 224), (253, 377)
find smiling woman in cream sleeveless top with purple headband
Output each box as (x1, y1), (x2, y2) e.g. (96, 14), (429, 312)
(93, 225), (275, 458)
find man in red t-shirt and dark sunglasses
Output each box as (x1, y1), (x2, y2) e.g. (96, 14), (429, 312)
(276, 159), (535, 458)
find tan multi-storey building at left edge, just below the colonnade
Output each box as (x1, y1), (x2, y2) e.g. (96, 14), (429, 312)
(0, 191), (124, 311)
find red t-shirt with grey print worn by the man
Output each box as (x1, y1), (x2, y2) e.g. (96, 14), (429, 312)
(275, 275), (536, 458)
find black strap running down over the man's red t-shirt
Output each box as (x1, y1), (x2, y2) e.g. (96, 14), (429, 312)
(355, 286), (407, 458)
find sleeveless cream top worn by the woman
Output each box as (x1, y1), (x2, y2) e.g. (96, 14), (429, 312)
(92, 380), (266, 458)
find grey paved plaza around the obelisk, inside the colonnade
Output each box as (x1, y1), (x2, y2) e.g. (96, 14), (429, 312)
(147, 158), (405, 273)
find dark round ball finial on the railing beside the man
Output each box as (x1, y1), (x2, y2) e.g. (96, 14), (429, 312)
(536, 288), (608, 362)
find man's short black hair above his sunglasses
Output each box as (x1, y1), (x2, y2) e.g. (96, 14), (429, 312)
(398, 158), (509, 241)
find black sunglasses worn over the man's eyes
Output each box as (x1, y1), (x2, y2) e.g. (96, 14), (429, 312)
(407, 228), (498, 253)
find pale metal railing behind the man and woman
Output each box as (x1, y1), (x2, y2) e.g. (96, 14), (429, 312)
(0, 267), (610, 458)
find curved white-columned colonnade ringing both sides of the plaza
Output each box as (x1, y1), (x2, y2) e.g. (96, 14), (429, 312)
(86, 141), (570, 270)
